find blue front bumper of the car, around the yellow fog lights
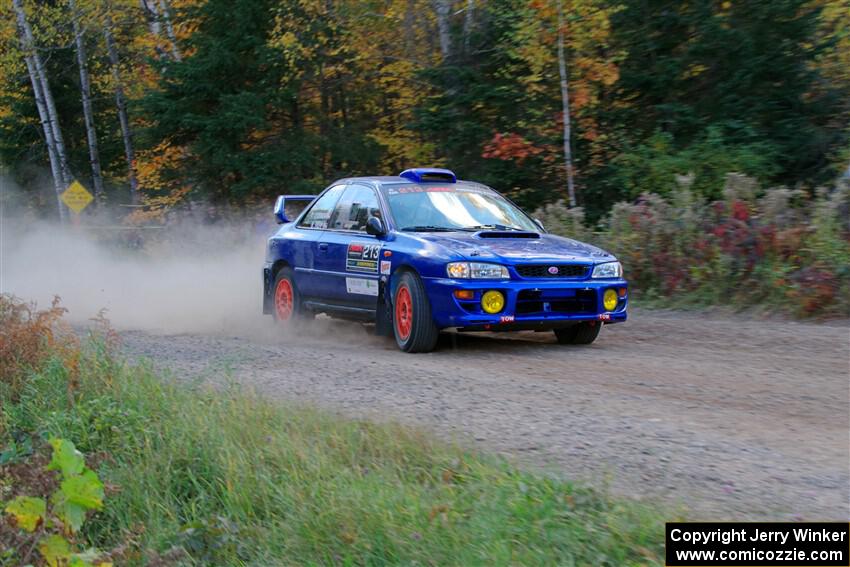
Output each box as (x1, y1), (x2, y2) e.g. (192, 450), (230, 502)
(423, 278), (629, 331)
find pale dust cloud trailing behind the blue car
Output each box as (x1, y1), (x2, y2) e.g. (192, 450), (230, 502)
(0, 179), (275, 334)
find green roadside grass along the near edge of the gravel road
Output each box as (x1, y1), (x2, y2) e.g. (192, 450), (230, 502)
(0, 300), (663, 566)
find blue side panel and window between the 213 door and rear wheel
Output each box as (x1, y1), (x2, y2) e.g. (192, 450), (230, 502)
(288, 185), (345, 298)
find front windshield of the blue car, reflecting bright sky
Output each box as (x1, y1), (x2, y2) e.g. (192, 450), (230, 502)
(387, 183), (539, 232)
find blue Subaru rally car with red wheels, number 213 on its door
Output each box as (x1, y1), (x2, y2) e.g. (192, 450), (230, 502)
(263, 169), (628, 352)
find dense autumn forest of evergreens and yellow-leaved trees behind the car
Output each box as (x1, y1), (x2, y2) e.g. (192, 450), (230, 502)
(0, 0), (850, 220)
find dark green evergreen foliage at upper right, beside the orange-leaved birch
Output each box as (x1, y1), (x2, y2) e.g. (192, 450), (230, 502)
(611, 0), (843, 184)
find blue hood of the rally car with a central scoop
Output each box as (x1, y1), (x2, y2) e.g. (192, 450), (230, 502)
(410, 232), (615, 264)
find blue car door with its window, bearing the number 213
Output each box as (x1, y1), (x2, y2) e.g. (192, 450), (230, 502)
(317, 183), (383, 309)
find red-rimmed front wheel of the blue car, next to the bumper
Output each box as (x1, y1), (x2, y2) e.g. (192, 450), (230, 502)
(392, 272), (440, 352)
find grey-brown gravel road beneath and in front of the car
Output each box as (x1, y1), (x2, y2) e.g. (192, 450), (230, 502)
(122, 311), (850, 520)
